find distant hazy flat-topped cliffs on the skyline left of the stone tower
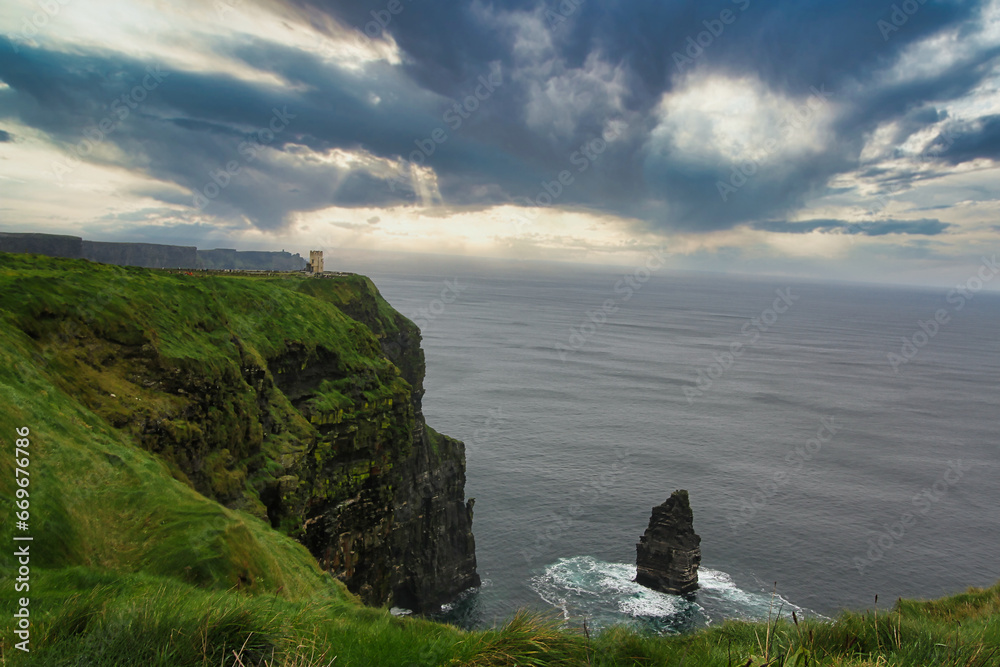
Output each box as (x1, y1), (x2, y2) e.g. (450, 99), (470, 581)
(0, 232), (306, 271)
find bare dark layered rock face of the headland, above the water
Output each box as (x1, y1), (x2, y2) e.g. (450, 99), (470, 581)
(262, 330), (479, 611)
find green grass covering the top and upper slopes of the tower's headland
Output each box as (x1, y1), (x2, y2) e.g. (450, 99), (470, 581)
(0, 254), (419, 524)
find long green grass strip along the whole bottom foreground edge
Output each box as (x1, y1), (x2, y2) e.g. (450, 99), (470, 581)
(0, 580), (1000, 667)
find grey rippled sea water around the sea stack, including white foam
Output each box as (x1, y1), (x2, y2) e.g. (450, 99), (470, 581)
(338, 258), (1000, 631)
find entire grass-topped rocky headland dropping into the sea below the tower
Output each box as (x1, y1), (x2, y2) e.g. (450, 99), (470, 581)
(0, 255), (479, 611)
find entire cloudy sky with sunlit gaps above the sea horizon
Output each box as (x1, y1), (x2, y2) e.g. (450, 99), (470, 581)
(0, 0), (1000, 285)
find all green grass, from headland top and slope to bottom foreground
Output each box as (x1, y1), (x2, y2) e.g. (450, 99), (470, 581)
(0, 255), (1000, 667)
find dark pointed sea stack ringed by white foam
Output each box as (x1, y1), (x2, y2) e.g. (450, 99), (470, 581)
(635, 490), (701, 595)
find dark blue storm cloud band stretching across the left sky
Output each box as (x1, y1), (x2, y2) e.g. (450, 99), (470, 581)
(0, 38), (540, 228)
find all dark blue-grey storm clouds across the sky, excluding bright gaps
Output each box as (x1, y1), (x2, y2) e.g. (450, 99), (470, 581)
(0, 0), (1000, 235)
